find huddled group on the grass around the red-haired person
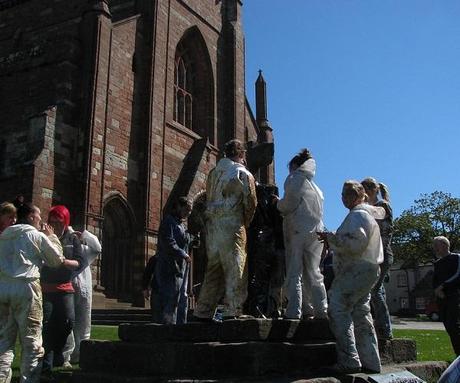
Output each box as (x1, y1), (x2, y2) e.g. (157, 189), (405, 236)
(0, 198), (101, 382)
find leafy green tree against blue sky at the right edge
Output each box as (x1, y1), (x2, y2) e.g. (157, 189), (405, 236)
(392, 191), (460, 267)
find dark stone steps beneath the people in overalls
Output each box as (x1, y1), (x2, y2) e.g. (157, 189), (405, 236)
(73, 319), (416, 383)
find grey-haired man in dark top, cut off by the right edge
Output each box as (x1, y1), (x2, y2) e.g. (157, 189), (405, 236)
(433, 236), (460, 356)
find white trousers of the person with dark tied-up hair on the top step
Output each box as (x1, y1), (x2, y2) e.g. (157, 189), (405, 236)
(284, 232), (327, 319)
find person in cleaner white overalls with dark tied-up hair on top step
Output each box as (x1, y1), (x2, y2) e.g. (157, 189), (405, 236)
(277, 149), (327, 319)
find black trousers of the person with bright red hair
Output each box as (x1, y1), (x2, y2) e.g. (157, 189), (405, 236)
(43, 292), (75, 371)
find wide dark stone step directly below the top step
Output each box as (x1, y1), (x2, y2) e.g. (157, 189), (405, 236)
(80, 341), (336, 378)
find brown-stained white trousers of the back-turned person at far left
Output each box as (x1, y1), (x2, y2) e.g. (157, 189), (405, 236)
(0, 277), (44, 383)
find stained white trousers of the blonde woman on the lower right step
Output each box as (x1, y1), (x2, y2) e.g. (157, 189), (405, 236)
(329, 260), (381, 371)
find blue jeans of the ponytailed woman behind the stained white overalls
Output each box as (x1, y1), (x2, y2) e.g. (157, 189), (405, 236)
(371, 259), (393, 339)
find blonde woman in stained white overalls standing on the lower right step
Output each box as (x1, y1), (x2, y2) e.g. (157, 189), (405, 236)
(317, 181), (383, 373)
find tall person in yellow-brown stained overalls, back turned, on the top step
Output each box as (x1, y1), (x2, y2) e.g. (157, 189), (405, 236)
(193, 140), (257, 321)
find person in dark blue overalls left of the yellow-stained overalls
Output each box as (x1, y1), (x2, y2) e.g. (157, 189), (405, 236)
(144, 197), (192, 324)
